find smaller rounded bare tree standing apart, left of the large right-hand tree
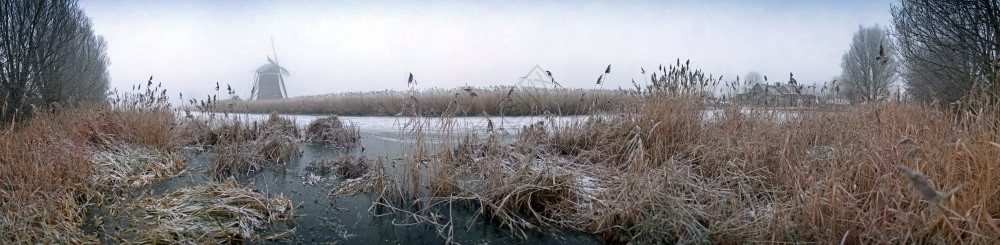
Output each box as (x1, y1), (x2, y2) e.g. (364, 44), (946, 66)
(840, 25), (899, 102)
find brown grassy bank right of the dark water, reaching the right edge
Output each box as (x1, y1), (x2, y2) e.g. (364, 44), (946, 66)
(354, 92), (1000, 244)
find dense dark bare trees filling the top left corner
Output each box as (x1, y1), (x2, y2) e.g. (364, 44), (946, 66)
(0, 0), (109, 120)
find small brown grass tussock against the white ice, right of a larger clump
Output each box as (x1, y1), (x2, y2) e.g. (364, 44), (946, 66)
(305, 115), (361, 147)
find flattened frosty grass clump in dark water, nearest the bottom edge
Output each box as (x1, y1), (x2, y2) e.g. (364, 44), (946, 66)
(134, 177), (293, 244)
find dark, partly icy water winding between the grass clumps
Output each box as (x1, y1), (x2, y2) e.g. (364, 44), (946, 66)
(95, 115), (601, 244)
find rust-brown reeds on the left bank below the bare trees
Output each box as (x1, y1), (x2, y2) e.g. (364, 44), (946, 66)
(0, 80), (179, 244)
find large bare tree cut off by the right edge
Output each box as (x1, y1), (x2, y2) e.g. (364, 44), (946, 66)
(892, 0), (1000, 103)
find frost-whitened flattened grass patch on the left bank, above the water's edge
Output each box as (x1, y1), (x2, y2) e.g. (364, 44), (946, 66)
(91, 145), (187, 187)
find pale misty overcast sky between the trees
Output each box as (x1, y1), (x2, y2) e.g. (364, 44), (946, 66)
(80, 0), (895, 103)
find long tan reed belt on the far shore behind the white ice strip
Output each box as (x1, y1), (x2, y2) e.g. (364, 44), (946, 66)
(213, 86), (633, 116)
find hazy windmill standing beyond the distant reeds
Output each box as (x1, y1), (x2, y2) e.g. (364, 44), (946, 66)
(250, 37), (288, 100)
